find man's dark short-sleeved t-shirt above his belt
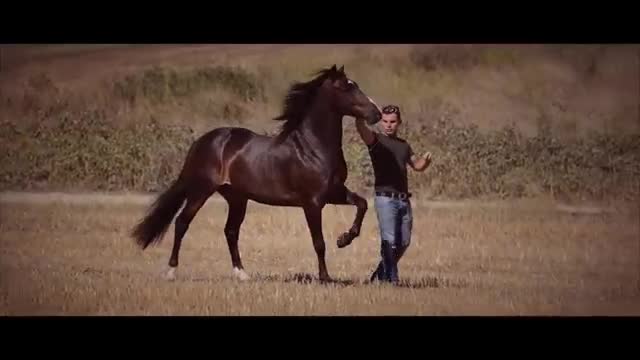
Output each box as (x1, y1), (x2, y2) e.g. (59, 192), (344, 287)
(368, 133), (413, 193)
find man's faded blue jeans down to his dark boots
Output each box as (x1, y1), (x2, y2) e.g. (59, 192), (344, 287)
(374, 196), (413, 282)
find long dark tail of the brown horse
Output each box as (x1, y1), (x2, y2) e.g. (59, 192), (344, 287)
(132, 177), (187, 249)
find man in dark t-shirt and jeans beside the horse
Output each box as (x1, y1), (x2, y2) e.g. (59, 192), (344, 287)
(356, 105), (431, 283)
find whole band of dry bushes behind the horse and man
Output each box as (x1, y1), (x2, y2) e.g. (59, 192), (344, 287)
(0, 111), (640, 200)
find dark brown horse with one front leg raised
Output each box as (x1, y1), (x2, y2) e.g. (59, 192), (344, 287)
(131, 64), (382, 282)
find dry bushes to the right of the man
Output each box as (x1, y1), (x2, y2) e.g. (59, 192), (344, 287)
(400, 114), (640, 200)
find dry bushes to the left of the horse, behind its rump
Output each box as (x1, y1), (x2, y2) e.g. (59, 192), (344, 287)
(0, 111), (194, 191)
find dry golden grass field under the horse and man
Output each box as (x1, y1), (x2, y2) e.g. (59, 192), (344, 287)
(0, 197), (640, 315)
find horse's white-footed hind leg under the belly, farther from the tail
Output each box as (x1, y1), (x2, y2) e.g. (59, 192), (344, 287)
(220, 187), (249, 280)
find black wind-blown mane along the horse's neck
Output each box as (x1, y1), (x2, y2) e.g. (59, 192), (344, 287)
(274, 67), (336, 136)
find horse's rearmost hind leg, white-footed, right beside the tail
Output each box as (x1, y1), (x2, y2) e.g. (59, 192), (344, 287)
(166, 187), (215, 280)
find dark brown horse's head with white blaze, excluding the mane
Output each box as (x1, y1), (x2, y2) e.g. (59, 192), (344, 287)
(323, 65), (382, 125)
